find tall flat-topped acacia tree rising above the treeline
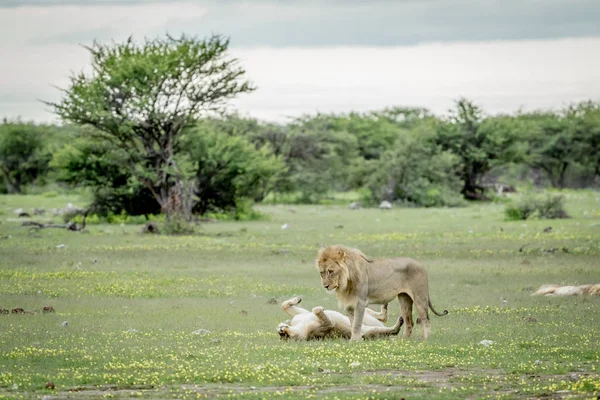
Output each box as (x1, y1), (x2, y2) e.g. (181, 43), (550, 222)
(47, 35), (254, 217)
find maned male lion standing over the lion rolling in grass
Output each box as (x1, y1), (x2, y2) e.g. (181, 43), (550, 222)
(317, 245), (448, 340)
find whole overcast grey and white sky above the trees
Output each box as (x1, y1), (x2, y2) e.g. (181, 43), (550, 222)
(0, 0), (600, 121)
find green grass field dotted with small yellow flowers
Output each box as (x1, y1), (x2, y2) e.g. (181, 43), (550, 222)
(0, 191), (600, 399)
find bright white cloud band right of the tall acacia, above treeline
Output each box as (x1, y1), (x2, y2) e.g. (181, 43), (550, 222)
(229, 39), (600, 120)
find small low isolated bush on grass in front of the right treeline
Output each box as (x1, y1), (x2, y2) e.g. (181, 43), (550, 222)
(504, 193), (568, 221)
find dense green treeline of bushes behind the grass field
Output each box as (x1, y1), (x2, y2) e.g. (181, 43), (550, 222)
(0, 99), (600, 215)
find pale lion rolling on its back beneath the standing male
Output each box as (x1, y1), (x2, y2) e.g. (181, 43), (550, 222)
(277, 296), (404, 340)
